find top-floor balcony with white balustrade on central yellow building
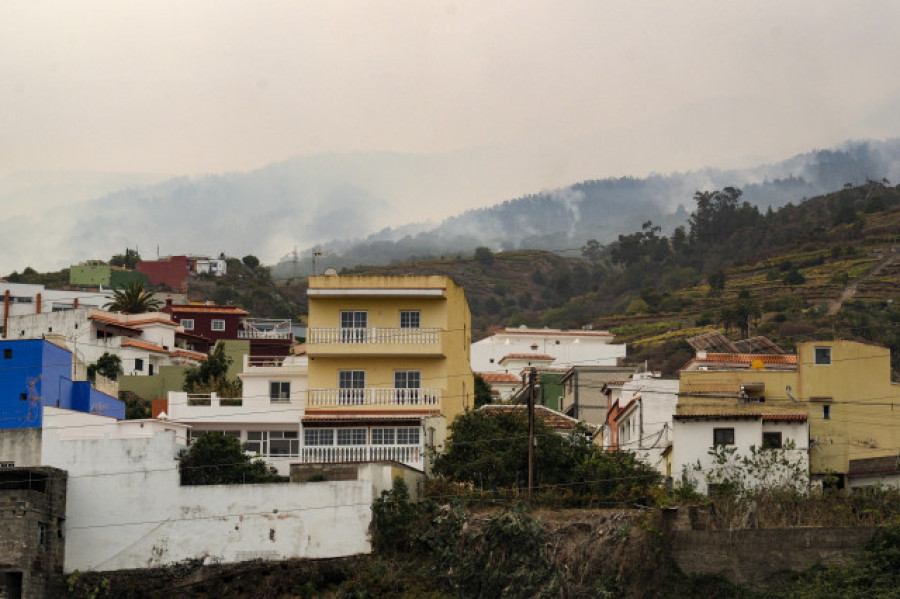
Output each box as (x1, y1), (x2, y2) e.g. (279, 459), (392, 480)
(307, 327), (442, 356)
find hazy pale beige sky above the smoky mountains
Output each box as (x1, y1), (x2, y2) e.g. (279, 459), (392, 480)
(0, 0), (900, 266)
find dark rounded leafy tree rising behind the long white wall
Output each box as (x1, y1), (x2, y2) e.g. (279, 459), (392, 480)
(178, 432), (287, 485)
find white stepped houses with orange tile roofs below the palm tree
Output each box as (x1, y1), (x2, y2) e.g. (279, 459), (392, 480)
(7, 307), (206, 380)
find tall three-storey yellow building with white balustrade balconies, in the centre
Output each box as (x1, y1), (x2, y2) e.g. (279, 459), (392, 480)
(303, 275), (474, 467)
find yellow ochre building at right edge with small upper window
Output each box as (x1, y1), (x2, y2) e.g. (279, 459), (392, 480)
(675, 341), (900, 487)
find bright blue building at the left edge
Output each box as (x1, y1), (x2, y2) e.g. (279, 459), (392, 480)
(0, 339), (125, 429)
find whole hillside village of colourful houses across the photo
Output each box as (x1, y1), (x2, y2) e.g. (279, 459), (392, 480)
(0, 256), (900, 597)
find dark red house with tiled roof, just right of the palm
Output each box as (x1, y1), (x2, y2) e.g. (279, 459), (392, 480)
(160, 299), (294, 356)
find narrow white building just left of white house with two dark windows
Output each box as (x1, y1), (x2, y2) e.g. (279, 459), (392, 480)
(603, 372), (678, 476)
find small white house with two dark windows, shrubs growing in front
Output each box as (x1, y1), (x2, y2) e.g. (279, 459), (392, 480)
(672, 413), (809, 493)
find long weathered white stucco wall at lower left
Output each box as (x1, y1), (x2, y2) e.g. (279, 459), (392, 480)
(42, 409), (389, 571)
